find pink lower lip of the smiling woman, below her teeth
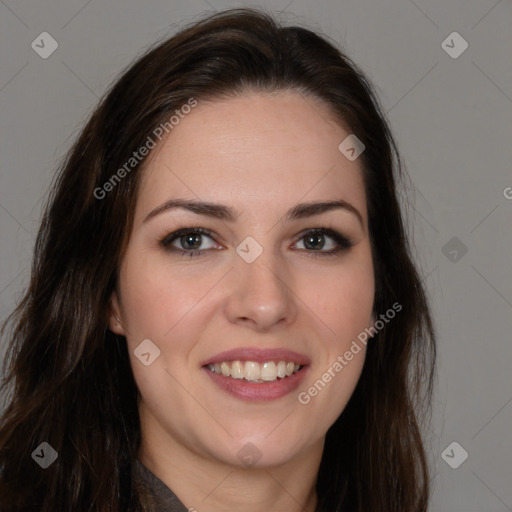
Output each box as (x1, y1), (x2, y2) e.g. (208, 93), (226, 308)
(203, 366), (309, 402)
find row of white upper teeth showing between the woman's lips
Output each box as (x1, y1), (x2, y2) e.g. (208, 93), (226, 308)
(205, 360), (303, 383)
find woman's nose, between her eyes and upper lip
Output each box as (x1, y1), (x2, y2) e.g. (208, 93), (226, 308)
(226, 251), (297, 332)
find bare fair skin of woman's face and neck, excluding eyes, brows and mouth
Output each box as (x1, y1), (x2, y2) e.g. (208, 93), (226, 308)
(110, 91), (375, 512)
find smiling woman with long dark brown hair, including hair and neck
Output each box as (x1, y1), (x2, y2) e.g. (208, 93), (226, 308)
(0, 9), (435, 512)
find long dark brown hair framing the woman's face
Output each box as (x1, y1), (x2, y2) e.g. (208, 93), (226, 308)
(0, 9), (435, 512)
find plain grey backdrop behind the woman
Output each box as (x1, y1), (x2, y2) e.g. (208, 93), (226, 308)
(0, 0), (512, 512)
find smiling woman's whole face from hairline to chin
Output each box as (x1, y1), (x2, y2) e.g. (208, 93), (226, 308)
(111, 91), (374, 466)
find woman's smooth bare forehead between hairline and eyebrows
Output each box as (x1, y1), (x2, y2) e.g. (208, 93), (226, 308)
(136, 91), (366, 226)
